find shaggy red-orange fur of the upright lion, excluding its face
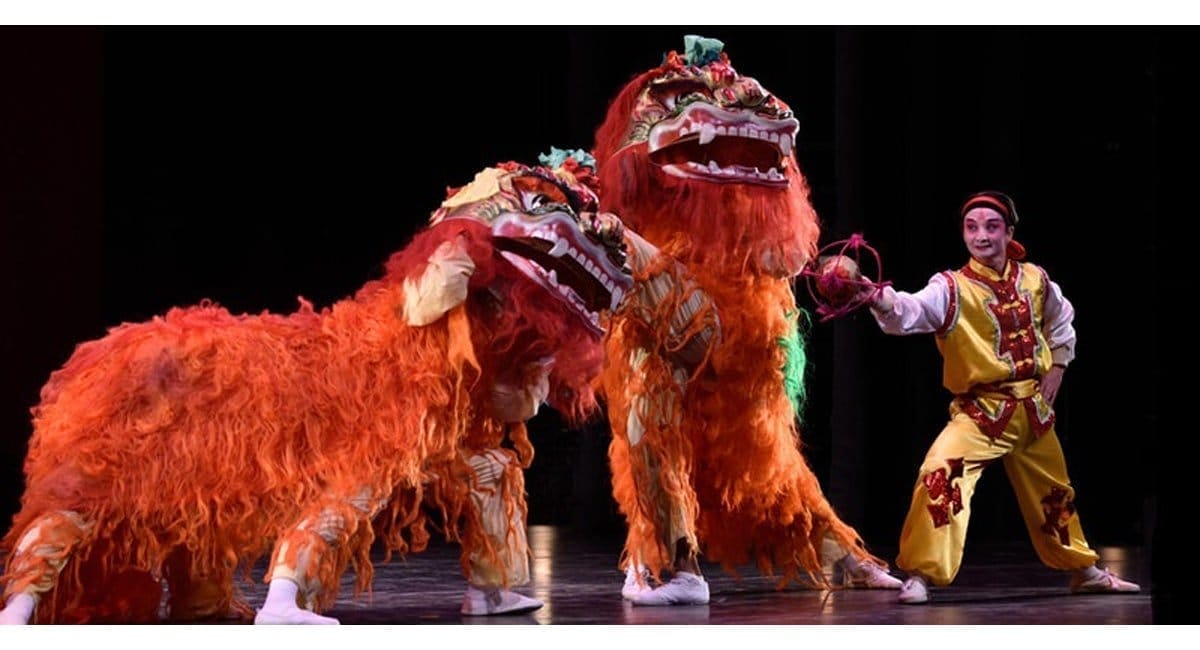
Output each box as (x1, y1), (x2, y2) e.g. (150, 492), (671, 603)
(595, 58), (877, 585)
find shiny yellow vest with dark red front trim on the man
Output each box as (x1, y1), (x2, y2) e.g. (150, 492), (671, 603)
(936, 259), (1054, 395)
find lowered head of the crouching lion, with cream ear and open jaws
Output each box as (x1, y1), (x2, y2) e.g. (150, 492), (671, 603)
(388, 149), (634, 419)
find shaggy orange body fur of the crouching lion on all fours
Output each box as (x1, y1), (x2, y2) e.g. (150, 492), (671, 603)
(0, 217), (590, 622)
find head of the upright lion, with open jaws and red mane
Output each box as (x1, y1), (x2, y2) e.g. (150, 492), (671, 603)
(594, 37), (818, 277)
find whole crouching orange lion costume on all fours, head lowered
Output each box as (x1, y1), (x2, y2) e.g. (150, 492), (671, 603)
(0, 154), (631, 622)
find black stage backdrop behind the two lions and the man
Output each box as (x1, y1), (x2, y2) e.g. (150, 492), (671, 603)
(0, 28), (1176, 580)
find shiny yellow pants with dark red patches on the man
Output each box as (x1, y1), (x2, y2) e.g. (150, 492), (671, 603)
(896, 399), (1098, 585)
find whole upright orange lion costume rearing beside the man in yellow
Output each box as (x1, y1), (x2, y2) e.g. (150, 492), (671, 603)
(594, 36), (900, 604)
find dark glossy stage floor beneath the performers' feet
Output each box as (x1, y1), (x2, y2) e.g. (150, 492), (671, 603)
(236, 526), (1152, 625)
